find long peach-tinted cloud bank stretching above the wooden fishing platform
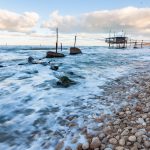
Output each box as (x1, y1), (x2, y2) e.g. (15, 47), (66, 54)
(42, 7), (150, 33)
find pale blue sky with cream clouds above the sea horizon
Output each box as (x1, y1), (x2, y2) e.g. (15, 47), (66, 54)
(0, 0), (150, 45)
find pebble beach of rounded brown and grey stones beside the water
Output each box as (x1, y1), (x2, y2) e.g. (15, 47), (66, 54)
(61, 69), (150, 150)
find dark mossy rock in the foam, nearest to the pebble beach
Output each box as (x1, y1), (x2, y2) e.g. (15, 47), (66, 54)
(57, 76), (75, 88)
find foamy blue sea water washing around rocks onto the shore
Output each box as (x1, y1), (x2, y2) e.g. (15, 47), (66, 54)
(0, 47), (150, 150)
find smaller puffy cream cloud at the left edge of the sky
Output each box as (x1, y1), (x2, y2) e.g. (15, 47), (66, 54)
(0, 9), (39, 32)
